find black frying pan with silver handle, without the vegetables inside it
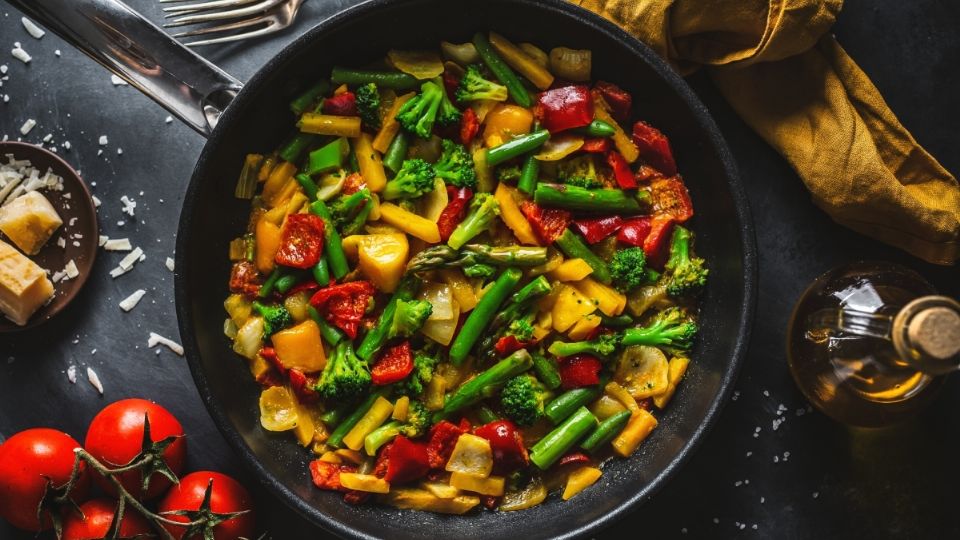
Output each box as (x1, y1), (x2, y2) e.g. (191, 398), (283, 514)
(11, 0), (756, 538)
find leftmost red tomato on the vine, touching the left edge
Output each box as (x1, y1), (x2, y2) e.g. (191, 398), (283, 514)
(0, 428), (90, 531)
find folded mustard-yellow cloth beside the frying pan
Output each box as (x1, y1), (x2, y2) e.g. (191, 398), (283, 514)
(571, 0), (960, 264)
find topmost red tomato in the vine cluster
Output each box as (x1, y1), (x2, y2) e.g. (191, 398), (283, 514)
(84, 399), (187, 499)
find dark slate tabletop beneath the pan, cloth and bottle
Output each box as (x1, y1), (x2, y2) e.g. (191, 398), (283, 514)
(0, 0), (960, 539)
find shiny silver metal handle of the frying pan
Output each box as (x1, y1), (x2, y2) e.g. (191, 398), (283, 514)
(8, 0), (243, 137)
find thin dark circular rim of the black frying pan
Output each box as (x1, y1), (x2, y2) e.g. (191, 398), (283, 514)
(174, 0), (757, 539)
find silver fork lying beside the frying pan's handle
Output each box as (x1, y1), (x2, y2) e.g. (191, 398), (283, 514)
(160, 0), (306, 47)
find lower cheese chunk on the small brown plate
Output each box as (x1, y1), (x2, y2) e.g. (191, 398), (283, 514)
(0, 240), (53, 326)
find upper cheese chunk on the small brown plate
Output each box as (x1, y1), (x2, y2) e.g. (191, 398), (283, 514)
(0, 191), (63, 255)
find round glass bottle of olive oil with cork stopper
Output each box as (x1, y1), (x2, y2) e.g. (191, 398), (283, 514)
(787, 262), (960, 427)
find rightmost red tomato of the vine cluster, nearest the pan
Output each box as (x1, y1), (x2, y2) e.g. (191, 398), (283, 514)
(157, 471), (255, 540)
